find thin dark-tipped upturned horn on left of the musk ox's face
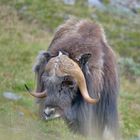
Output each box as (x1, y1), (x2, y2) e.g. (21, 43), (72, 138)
(25, 84), (47, 98)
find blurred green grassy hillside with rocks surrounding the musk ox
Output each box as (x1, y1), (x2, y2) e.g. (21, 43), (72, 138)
(0, 0), (140, 140)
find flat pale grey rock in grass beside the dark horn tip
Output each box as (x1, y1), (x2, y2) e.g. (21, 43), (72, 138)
(3, 92), (21, 101)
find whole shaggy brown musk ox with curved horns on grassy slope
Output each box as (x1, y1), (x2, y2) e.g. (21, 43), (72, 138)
(27, 19), (119, 140)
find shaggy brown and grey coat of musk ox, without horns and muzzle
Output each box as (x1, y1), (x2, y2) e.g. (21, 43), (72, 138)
(35, 19), (119, 140)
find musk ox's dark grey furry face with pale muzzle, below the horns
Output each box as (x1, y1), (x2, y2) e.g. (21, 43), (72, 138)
(41, 75), (78, 119)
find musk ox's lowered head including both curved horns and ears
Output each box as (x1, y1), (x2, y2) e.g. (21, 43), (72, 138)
(26, 52), (99, 119)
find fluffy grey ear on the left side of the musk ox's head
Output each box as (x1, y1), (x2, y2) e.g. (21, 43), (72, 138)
(33, 51), (51, 72)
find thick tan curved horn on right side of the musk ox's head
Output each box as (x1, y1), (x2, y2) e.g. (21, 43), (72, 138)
(59, 55), (100, 104)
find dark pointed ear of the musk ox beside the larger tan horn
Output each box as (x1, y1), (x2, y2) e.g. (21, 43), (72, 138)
(79, 53), (91, 67)
